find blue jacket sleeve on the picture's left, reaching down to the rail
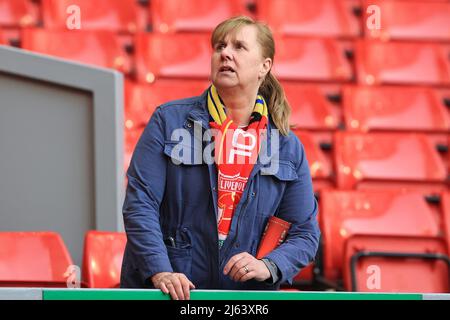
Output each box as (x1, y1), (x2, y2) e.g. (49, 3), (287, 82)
(123, 108), (173, 281)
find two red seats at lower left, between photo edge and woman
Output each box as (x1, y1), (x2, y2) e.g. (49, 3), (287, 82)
(0, 231), (126, 288)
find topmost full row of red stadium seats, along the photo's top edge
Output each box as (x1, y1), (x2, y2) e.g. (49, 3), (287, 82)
(0, 0), (450, 41)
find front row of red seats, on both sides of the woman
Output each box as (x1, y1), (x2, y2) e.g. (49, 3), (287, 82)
(0, 190), (450, 293)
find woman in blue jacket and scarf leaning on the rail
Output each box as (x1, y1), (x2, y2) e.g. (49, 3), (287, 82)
(121, 17), (320, 299)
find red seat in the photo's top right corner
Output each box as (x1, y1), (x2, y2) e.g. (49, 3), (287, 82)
(364, 0), (450, 41)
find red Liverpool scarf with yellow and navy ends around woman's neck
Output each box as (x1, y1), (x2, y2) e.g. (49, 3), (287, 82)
(207, 85), (267, 248)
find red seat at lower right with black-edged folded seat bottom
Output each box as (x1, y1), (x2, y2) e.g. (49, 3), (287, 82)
(320, 190), (450, 292)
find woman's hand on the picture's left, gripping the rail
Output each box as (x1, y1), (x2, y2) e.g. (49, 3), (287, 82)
(151, 272), (195, 300)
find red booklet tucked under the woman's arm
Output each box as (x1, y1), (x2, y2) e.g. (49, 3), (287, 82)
(256, 216), (291, 259)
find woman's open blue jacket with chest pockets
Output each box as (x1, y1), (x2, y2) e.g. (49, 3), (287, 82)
(121, 92), (320, 290)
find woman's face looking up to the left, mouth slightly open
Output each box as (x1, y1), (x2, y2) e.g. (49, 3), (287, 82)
(211, 26), (272, 91)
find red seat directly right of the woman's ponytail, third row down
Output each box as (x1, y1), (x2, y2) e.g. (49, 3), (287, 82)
(282, 82), (341, 130)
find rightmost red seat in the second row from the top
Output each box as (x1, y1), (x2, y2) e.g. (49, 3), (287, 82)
(355, 40), (450, 85)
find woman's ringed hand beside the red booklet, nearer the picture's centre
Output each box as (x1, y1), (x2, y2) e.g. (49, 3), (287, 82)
(223, 252), (270, 282)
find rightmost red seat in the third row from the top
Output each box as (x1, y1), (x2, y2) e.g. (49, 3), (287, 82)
(343, 86), (450, 133)
